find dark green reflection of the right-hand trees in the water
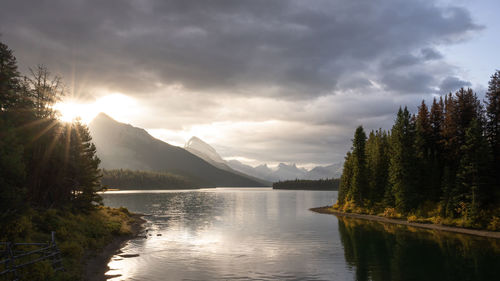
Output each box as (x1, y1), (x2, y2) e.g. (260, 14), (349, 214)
(338, 217), (500, 281)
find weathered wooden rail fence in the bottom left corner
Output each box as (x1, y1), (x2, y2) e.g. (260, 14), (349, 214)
(0, 232), (64, 280)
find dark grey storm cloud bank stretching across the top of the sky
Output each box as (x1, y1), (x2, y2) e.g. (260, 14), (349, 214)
(0, 0), (480, 99)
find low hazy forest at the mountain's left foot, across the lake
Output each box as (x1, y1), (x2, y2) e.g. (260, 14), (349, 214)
(101, 169), (199, 189)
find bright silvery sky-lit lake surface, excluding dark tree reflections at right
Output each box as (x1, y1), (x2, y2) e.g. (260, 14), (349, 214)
(100, 189), (344, 280)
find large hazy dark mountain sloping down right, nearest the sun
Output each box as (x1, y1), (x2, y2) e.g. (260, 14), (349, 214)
(89, 113), (266, 187)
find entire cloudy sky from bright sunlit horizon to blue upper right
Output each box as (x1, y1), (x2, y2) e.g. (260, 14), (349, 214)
(0, 0), (500, 167)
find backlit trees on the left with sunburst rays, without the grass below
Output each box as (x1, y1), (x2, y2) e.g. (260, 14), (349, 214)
(0, 42), (101, 235)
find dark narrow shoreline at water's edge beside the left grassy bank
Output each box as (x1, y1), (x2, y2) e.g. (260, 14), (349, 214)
(83, 214), (146, 281)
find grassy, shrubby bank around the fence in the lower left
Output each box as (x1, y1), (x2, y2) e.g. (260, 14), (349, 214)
(0, 206), (134, 280)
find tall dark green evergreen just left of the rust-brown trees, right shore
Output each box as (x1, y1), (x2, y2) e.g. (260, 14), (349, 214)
(389, 107), (420, 213)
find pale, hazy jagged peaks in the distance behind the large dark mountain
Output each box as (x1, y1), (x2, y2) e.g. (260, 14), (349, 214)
(184, 137), (342, 182)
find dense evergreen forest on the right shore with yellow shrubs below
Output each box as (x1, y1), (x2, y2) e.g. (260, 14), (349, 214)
(334, 71), (500, 231)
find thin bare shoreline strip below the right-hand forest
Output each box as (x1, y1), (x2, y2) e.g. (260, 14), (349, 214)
(309, 206), (500, 239)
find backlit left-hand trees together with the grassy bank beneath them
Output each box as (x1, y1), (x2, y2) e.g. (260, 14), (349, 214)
(0, 42), (137, 280)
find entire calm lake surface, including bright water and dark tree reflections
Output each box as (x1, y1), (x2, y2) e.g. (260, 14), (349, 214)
(103, 188), (500, 281)
